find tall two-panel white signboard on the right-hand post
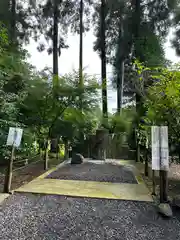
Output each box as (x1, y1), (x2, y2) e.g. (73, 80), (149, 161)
(151, 126), (169, 171)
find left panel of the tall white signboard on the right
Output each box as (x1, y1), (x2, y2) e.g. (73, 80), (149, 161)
(151, 126), (160, 170)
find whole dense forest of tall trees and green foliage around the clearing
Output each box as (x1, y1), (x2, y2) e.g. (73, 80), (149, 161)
(0, 0), (180, 167)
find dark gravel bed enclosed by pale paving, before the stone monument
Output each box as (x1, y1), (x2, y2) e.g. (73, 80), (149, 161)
(47, 162), (137, 184)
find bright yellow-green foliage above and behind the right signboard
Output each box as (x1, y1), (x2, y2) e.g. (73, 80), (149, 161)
(134, 61), (180, 152)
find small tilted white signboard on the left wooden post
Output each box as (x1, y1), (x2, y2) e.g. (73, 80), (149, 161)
(6, 127), (23, 147)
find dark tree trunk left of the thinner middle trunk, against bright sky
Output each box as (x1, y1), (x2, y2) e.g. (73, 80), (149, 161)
(53, 0), (58, 79)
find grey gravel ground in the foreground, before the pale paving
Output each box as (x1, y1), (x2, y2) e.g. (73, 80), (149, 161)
(0, 194), (180, 240)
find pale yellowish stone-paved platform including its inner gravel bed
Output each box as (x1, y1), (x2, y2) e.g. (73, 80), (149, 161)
(13, 162), (152, 202)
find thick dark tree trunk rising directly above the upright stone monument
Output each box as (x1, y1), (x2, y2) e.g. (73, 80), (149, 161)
(101, 0), (108, 123)
